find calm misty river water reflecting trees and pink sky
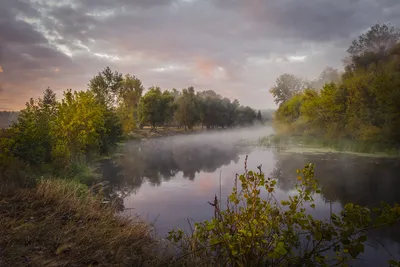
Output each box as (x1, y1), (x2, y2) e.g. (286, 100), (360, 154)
(103, 128), (400, 266)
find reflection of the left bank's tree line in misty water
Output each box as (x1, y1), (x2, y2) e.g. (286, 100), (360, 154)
(102, 128), (266, 195)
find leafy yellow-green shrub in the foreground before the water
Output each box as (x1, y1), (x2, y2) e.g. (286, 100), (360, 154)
(168, 158), (400, 266)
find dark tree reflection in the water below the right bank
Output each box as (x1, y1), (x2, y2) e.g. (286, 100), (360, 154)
(271, 153), (400, 207)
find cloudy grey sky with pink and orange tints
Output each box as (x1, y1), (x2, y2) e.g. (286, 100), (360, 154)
(0, 0), (400, 110)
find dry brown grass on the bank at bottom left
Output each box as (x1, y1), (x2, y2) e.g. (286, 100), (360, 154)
(0, 180), (158, 267)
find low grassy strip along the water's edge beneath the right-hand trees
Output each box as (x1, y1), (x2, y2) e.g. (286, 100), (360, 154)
(259, 135), (400, 157)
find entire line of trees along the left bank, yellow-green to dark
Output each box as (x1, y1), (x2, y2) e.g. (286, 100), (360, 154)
(0, 67), (262, 166)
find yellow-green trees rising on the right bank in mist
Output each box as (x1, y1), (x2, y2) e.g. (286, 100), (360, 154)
(270, 24), (400, 147)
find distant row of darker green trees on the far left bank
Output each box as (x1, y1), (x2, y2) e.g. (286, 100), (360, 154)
(138, 87), (263, 130)
